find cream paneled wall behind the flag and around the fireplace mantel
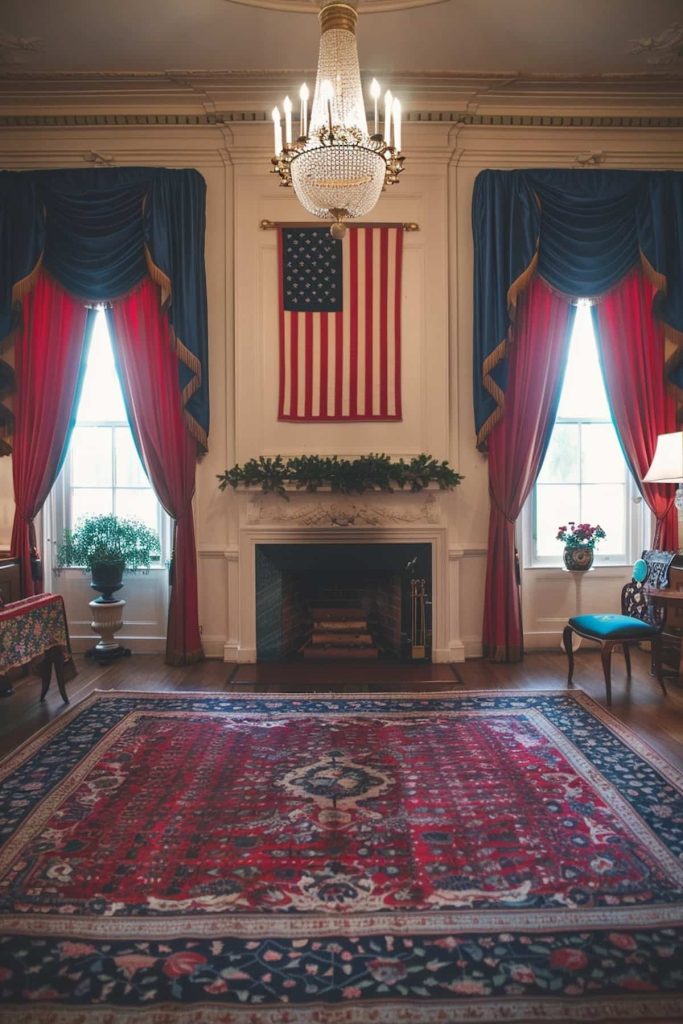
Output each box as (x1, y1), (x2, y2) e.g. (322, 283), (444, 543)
(0, 116), (683, 656)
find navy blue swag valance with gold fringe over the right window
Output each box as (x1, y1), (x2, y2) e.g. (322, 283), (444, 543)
(472, 170), (683, 449)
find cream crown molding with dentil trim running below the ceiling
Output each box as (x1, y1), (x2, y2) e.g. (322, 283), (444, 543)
(0, 68), (683, 118)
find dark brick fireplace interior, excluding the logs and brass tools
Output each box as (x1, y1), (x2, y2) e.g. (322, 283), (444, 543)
(256, 544), (431, 662)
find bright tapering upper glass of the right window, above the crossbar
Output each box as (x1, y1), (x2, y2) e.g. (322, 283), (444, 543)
(557, 302), (609, 420)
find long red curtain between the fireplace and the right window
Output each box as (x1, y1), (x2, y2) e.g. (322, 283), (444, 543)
(483, 278), (575, 662)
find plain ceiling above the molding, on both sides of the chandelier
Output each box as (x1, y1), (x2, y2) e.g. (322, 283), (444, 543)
(0, 0), (683, 80)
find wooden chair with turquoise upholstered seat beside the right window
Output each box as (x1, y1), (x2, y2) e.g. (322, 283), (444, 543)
(563, 559), (667, 705)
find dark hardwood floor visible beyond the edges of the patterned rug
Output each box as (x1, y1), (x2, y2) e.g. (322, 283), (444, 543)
(0, 647), (683, 767)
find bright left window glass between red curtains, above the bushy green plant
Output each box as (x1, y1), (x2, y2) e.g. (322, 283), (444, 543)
(53, 309), (169, 563)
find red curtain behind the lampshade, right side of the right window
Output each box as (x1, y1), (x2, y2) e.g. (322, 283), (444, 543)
(592, 267), (678, 551)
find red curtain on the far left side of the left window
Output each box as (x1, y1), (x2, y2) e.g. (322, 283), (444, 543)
(11, 272), (87, 597)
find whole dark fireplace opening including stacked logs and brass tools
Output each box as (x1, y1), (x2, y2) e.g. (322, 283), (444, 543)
(255, 543), (432, 662)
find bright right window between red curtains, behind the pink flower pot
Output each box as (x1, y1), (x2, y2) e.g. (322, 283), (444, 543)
(526, 302), (642, 565)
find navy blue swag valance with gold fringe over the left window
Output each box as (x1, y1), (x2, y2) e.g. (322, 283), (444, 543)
(0, 167), (209, 455)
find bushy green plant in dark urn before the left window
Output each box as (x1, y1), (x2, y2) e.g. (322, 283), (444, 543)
(57, 515), (161, 603)
